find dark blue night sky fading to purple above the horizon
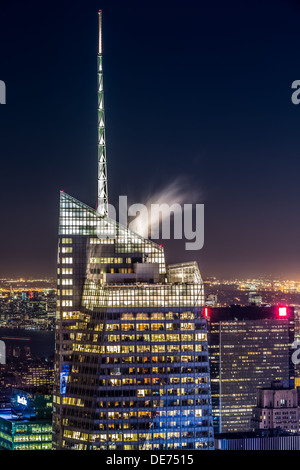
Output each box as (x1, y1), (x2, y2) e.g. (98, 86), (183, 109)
(0, 0), (300, 279)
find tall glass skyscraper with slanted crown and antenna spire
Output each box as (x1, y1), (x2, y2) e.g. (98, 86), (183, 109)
(53, 11), (213, 450)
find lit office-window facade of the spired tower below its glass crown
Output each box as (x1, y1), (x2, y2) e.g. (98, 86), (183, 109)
(57, 309), (212, 450)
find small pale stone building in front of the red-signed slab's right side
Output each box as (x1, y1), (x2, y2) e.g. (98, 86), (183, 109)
(252, 381), (299, 433)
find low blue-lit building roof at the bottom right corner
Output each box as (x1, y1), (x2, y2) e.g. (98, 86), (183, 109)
(215, 429), (300, 450)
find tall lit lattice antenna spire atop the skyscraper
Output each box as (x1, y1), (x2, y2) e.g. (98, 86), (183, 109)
(97, 10), (108, 216)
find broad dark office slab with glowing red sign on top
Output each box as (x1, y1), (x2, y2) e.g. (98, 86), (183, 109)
(206, 306), (294, 433)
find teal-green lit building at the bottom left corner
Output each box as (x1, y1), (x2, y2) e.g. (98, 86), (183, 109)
(0, 390), (52, 450)
